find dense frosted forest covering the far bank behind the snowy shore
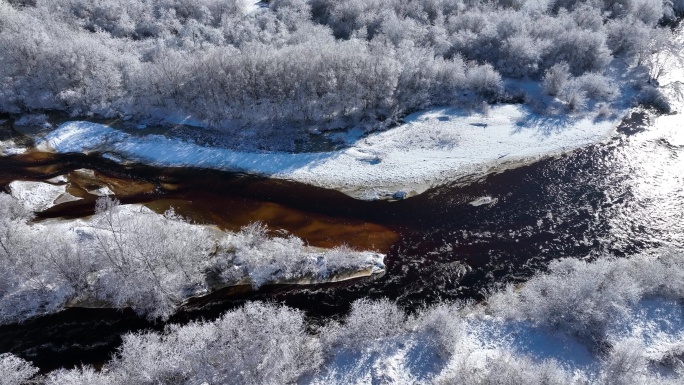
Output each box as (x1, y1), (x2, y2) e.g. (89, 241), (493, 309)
(0, 0), (684, 134)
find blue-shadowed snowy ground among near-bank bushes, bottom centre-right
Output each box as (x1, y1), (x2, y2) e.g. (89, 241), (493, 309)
(300, 314), (599, 385)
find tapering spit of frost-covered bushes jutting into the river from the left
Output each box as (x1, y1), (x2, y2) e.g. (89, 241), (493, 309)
(0, 194), (382, 323)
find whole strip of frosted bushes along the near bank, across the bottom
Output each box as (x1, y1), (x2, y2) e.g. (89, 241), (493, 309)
(10, 250), (684, 385)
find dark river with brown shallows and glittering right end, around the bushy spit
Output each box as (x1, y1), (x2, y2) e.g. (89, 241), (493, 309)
(0, 112), (684, 370)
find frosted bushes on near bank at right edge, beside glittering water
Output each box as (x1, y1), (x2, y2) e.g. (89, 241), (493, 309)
(489, 250), (684, 348)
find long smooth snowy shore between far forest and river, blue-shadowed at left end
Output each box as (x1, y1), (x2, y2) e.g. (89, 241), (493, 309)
(38, 105), (619, 200)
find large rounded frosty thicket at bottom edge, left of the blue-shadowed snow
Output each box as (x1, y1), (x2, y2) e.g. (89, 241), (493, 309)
(94, 303), (322, 385)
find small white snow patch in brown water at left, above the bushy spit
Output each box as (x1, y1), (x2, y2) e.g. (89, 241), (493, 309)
(9, 181), (80, 211)
